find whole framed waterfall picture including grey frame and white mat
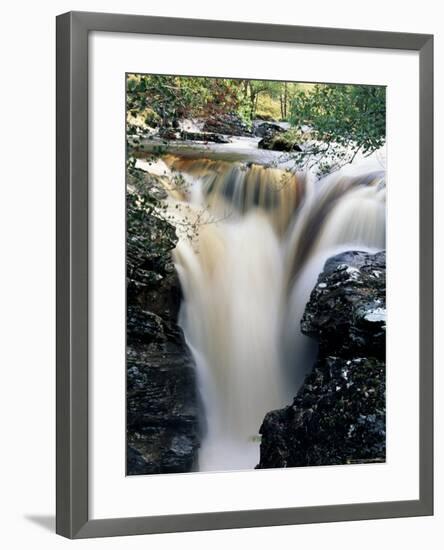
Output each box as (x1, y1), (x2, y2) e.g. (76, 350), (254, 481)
(57, 12), (433, 538)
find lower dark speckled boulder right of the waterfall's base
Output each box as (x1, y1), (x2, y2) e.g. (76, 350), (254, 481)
(259, 356), (385, 468)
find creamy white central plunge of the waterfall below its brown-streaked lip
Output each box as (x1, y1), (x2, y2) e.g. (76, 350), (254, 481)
(176, 212), (284, 470)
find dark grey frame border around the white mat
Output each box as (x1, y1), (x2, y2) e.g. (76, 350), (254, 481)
(56, 12), (433, 538)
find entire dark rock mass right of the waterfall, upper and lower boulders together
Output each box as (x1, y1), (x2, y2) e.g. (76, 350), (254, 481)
(257, 251), (386, 468)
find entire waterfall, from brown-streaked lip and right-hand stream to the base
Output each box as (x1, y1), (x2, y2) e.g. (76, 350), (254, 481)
(139, 151), (385, 471)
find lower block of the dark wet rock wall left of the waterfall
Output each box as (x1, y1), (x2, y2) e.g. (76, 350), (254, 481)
(127, 340), (199, 475)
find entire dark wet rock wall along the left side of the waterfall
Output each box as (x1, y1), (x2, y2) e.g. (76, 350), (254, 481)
(127, 188), (200, 475)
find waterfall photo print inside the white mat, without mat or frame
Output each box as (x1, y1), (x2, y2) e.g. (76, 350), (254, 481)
(125, 74), (386, 475)
